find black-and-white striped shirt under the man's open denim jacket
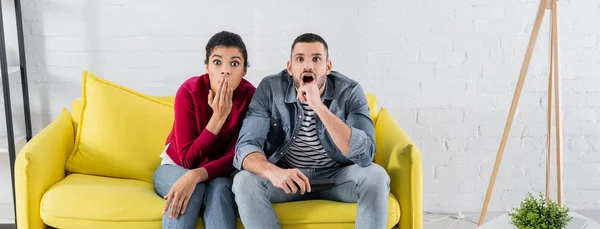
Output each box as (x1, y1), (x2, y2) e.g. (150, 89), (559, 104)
(280, 103), (339, 168)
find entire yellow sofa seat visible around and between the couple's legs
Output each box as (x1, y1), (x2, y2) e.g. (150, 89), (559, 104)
(40, 174), (400, 228)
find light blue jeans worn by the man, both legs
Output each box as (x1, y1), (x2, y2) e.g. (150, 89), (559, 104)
(233, 164), (390, 229)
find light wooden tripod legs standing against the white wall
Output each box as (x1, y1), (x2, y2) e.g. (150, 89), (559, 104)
(478, 0), (563, 226)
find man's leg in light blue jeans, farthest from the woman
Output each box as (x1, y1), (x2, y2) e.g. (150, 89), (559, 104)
(315, 164), (390, 229)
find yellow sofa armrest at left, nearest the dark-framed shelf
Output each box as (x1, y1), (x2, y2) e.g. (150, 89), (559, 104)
(15, 109), (75, 229)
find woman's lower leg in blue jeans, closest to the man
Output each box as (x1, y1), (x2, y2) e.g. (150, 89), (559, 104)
(202, 177), (237, 229)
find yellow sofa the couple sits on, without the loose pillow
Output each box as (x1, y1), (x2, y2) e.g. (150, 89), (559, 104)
(10, 72), (423, 229)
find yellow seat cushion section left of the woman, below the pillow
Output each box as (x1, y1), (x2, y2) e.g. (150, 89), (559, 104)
(40, 174), (165, 228)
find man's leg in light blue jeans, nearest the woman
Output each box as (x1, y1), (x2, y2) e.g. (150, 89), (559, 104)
(233, 170), (308, 229)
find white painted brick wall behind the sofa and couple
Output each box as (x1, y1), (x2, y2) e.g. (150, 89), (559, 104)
(2, 0), (600, 211)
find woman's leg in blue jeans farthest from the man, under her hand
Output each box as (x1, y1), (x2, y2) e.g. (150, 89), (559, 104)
(154, 164), (205, 229)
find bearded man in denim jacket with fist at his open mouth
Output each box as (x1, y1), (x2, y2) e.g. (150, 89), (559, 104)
(232, 33), (390, 229)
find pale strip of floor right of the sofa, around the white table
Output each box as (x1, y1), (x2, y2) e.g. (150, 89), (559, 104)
(424, 211), (600, 229)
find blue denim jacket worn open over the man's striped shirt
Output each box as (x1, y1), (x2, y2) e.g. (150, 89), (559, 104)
(233, 70), (375, 170)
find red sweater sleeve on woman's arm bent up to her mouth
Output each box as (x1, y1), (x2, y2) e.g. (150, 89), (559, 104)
(174, 87), (217, 169)
